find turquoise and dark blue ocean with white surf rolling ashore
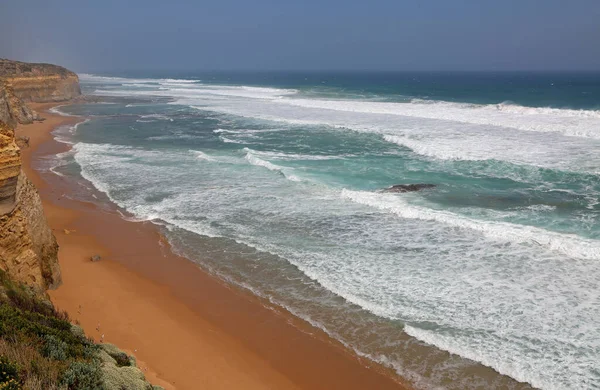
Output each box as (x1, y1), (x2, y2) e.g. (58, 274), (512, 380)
(45, 72), (600, 390)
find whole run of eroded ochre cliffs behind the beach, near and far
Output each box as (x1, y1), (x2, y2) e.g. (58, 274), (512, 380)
(0, 60), (74, 291)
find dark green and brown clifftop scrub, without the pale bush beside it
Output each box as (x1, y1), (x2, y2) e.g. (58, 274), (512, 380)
(0, 280), (102, 390)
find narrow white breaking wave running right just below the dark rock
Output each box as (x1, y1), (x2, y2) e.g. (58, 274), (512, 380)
(341, 189), (600, 260)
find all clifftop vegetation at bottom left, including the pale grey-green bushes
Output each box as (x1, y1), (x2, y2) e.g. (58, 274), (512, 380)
(0, 271), (158, 390)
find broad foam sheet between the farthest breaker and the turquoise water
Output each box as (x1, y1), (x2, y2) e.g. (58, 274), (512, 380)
(179, 92), (600, 174)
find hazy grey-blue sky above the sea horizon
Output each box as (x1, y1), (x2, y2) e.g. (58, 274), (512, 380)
(0, 0), (600, 72)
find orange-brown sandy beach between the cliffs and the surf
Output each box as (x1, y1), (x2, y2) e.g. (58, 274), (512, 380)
(17, 103), (407, 389)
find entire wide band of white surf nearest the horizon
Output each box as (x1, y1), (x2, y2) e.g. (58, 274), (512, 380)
(85, 76), (600, 173)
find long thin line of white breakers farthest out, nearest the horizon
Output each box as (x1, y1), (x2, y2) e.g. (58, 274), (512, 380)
(85, 76), (600, 139)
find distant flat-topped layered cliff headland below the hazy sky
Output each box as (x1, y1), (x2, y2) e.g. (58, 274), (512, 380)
(0, 59), (81, 102)
